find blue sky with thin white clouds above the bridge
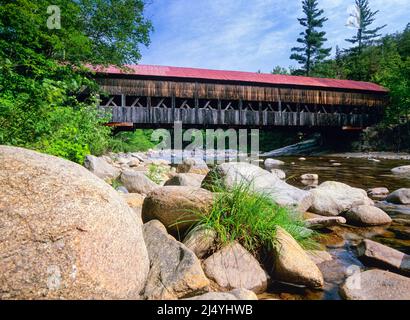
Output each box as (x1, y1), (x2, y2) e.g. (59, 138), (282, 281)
(140, 0), (410, 72)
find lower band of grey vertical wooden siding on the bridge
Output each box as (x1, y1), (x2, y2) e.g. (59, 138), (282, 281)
(101, 107), (373, 127)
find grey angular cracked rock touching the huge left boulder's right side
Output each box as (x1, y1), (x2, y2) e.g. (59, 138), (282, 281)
(144, 220), (209, 300)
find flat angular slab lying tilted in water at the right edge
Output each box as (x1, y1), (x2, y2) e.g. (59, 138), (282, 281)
(357, 239), (410, 275)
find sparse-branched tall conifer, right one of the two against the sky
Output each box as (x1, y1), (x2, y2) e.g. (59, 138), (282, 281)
(346, 0), (387, 53)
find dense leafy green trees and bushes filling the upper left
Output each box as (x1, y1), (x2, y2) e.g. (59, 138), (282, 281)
(0, 0), (151, 163)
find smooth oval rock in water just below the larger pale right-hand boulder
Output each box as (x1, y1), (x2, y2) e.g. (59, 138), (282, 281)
(346, 206), (392, 226)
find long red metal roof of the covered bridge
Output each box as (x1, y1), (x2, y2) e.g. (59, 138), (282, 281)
(91, 65), (388, 92)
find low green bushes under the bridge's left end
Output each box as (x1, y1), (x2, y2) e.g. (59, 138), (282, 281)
(108, 130), (155, 153)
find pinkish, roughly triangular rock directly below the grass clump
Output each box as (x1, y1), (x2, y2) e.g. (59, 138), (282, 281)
(203, 243), (268, 293)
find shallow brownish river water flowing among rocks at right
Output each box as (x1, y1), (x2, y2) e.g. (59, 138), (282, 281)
(260, 157), (410, 300)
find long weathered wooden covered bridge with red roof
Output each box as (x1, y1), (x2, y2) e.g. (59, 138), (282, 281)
(94, 65), (388, 129)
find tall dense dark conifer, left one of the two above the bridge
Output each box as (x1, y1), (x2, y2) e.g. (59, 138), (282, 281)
(290, 0), (332, 76)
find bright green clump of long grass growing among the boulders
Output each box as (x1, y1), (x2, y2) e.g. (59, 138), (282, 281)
(191, 184), (317, 254)
